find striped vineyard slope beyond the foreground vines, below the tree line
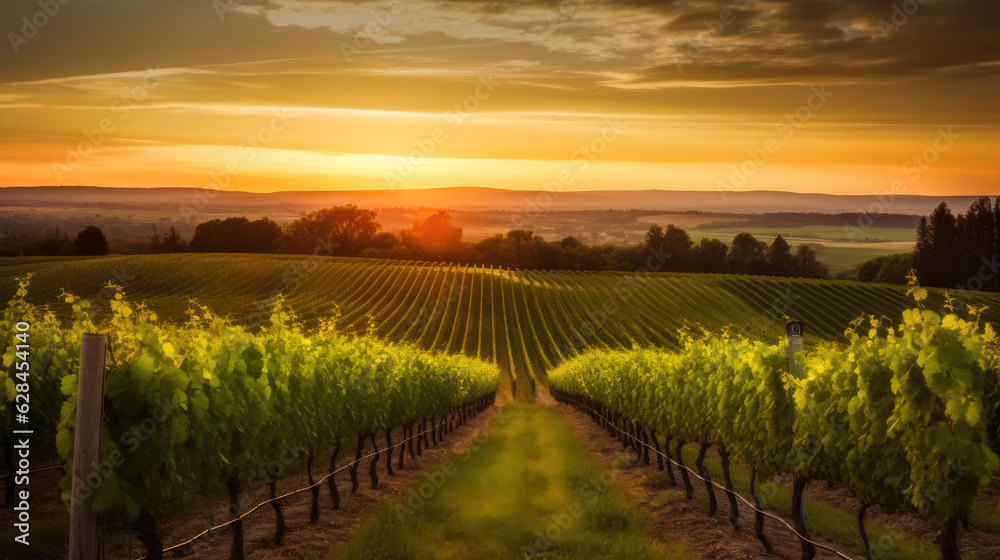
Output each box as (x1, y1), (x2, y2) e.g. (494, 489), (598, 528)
(0, 254), (1000, 395)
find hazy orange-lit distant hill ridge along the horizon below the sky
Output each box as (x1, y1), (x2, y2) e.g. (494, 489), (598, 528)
(0, 186), (977, 215)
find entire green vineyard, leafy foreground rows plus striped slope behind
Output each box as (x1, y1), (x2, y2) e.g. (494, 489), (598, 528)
(0, 255), (1000, 560)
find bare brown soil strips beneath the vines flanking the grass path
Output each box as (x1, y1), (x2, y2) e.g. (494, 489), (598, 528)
(7, 391), (1000, 560)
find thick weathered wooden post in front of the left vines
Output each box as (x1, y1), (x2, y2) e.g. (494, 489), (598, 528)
(69, 334), (105, 560)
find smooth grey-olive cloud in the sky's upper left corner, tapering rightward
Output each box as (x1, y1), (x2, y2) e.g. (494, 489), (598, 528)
(0, 0), (345, 82)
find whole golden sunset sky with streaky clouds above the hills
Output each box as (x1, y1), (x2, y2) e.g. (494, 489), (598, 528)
(0, 0), (1000, 195)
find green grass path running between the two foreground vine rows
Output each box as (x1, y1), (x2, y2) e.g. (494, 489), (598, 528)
(329, 403), (697, 560)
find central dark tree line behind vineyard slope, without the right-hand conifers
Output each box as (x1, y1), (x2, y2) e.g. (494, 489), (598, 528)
(141, 205), (829, 278)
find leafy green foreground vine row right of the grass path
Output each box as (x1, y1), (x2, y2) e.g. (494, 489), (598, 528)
(549, 276), (1000, 560)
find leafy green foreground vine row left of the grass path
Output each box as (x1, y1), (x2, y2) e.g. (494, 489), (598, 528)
(0, 281), (499, 560)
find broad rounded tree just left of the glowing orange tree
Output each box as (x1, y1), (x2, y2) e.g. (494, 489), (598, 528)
(281, 204), (382, 256)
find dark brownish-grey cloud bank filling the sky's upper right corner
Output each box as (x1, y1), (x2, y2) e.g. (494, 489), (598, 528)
(640, 0), (1000, 84)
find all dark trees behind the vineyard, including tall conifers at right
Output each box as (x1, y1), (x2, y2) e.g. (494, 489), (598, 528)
(22, 197), (1000, 292)
